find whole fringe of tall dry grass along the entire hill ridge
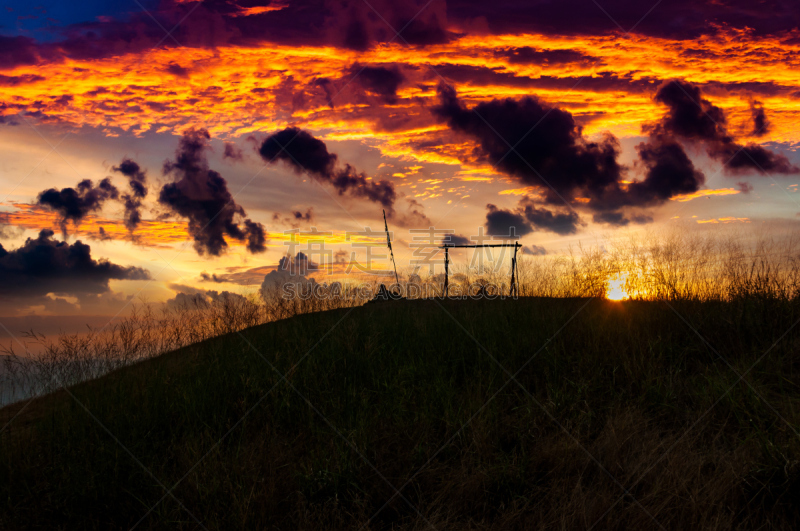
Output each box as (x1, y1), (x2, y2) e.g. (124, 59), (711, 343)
(0, 233), (800, 404)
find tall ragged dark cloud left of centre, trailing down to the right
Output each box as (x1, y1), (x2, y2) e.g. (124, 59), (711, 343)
(158, 129), (266, 256)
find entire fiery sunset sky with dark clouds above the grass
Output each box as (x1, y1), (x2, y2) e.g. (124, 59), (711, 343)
(0, 0), (800, 318)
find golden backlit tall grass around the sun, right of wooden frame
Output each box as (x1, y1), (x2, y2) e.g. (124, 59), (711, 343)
(518, 233), (800, 301)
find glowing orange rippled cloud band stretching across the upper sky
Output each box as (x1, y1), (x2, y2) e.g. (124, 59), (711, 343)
(6, 27), (800, 153)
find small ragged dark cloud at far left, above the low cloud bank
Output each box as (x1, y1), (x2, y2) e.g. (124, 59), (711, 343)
(36, 177), (119, 236)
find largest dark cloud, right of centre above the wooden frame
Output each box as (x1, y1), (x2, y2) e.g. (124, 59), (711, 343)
(433, 85), (705, 227)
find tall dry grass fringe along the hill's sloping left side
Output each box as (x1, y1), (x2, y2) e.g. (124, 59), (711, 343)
(0, 282), (364, 405)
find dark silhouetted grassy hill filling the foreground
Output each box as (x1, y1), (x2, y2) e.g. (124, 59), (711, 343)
(0, 298), (800, 529)
